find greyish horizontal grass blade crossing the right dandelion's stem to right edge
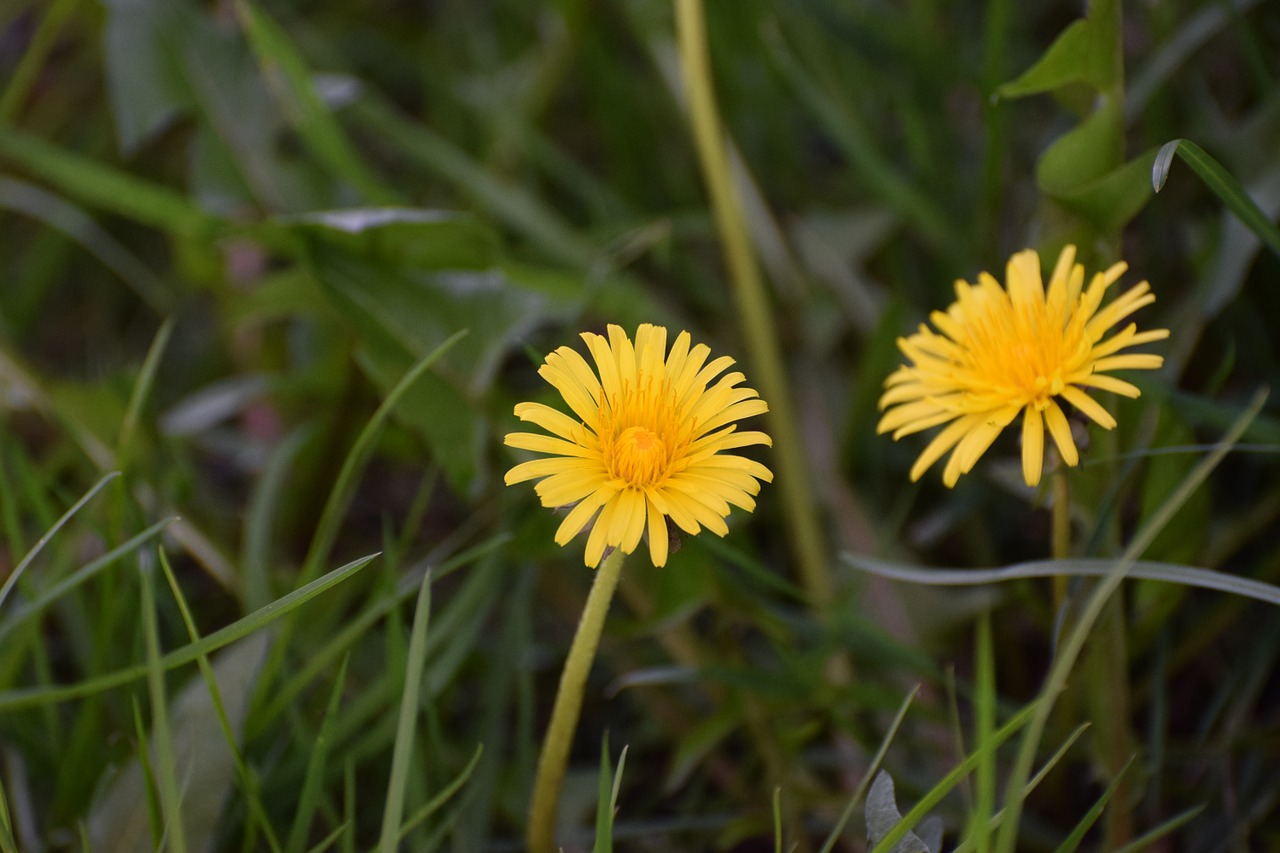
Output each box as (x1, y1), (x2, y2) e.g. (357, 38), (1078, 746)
(841, 553), (1280, 606)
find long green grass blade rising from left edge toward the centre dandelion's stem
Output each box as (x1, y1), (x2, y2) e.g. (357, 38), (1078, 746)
(0, 553), (378, 711)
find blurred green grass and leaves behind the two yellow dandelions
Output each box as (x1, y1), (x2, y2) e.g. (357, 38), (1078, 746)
(0, 0), (1280, 850)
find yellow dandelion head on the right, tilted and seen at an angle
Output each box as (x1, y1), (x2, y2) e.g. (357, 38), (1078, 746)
(877, 246), (1169, 487)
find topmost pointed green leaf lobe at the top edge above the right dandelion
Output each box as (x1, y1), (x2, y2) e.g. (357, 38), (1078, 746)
(996, 0), (1123, 97)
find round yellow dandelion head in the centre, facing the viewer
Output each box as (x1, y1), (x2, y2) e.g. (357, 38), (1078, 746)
(506, 323), (773, 566)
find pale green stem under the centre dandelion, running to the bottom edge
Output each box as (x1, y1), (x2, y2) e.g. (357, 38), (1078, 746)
(526, 549), (622, 853)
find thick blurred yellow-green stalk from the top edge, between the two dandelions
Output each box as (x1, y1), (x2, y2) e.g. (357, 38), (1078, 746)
(675, 0), (832, 606)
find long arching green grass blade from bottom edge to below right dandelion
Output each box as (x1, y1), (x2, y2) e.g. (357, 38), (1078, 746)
(996, 389), (1267, 853)
